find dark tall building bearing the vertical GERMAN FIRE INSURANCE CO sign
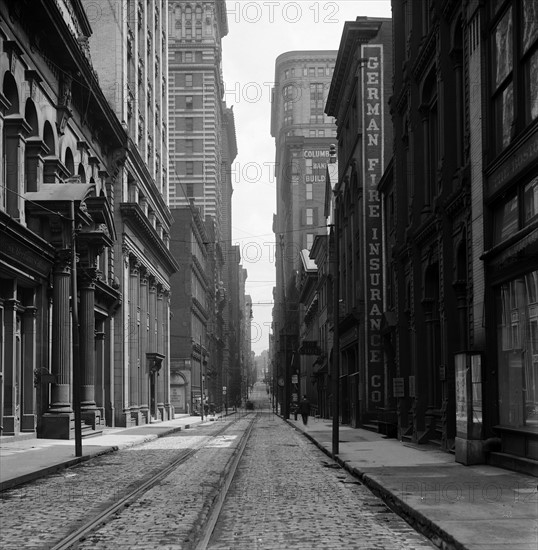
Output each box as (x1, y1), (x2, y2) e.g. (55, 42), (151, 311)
(326, 17), (396, 427)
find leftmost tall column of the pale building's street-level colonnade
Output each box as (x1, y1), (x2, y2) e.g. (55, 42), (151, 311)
(127, 258), (140, 425)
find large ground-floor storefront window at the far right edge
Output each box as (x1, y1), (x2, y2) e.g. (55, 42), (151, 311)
(496, 271), (538, 432)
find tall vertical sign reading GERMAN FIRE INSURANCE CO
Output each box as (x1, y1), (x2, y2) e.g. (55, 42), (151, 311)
(361, 44), (385, 412)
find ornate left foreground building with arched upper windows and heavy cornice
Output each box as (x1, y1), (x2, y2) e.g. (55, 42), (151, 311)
(0, 0), (127, 439)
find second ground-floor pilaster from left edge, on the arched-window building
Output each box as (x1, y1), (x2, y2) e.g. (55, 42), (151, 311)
(21, 306), (37, 432)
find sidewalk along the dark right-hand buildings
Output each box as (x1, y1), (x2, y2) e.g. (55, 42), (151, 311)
(288, 417), (538, 550)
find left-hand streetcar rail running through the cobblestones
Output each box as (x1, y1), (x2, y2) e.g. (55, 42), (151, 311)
(51, 418), (253, 550)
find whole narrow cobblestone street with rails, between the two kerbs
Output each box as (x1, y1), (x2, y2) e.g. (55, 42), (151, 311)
(0, 384), (433, 550)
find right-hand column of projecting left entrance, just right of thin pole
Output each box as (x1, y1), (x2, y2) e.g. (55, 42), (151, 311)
(78, 268), (100, 429)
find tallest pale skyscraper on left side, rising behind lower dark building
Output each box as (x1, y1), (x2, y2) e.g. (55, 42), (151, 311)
(168, 0), (238, 414)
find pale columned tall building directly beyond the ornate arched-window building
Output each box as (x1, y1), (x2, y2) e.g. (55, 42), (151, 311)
(83, 0), (179, 426)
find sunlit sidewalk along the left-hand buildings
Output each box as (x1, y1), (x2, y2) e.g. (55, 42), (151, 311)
(0, 415), (207, 492)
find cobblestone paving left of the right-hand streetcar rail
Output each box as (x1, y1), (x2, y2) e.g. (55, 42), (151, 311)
(0, 421), (246, 550)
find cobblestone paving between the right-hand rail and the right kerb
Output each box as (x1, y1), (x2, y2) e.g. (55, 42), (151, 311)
(209, 414), (435, 550)
